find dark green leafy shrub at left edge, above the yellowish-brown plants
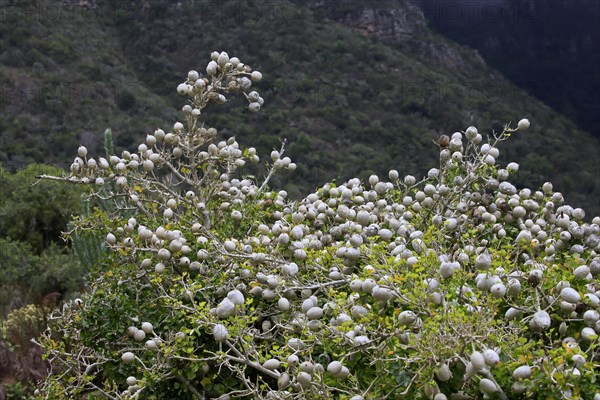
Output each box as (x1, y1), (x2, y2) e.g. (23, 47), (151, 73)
(0, 164), (84, 308)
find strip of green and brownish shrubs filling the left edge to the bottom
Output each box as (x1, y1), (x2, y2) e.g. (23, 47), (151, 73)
(0, 164), (86, 399)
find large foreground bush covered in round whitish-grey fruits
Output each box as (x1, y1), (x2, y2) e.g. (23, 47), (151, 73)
(38, 52), (600, 400)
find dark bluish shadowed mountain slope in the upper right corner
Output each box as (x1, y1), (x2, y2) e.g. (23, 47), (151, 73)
(413, 0), (600, 137)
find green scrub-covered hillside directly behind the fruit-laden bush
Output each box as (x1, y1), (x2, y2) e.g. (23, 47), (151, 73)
(0, 0), (600, 213)
